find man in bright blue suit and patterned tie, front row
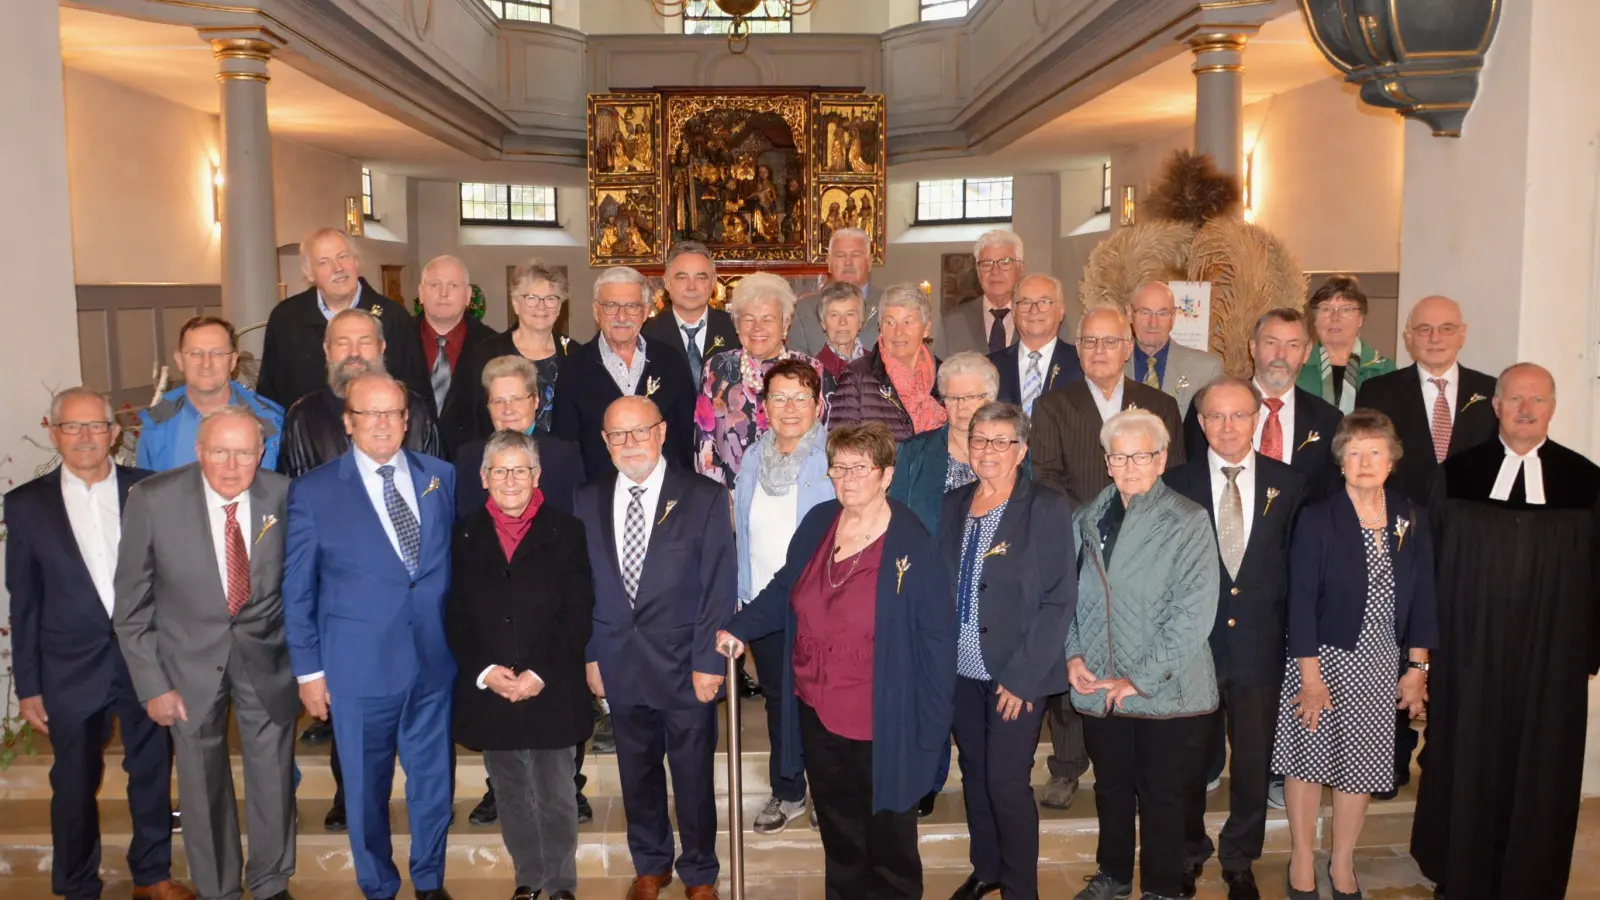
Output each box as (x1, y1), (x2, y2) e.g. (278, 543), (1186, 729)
(283, 375), (456, 900)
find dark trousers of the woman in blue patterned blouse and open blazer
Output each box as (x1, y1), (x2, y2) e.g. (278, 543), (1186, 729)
(954, 677), (1045, 900)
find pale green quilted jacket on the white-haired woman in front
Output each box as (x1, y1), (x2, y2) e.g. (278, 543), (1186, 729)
(1067, 480), (1221, 719)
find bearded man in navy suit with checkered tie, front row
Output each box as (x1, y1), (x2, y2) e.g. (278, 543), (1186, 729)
(578, 397), (739, 900)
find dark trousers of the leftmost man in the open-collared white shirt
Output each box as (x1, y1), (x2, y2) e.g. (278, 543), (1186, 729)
(45, 676), (173, 900)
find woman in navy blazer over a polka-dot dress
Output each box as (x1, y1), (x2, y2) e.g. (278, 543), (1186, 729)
(1272, 410), (1438, 900)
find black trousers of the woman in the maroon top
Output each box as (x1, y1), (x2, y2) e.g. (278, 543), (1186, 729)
(800, 703), (922, 900)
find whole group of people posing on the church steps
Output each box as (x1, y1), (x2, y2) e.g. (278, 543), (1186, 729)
(6, 219), (1600, 900)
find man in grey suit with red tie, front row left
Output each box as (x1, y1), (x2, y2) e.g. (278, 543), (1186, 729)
(114, 407), (299, 900)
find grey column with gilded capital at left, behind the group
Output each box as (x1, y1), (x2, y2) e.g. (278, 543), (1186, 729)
(205, 35), (278, 328)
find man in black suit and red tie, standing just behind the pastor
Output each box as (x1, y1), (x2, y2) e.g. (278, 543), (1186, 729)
(1355, 296), (1499, 799)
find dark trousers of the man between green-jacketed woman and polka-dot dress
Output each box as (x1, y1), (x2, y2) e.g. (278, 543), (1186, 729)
(1184, 677), (1280, 871)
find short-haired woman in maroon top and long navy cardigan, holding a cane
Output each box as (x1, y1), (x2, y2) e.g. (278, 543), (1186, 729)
(717, 423), (955, 900)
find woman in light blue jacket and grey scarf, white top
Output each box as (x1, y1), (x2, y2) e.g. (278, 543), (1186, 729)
(733, 360), (834, 834)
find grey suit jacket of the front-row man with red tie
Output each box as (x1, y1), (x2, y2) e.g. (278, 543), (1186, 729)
(112, 463), (299, 729)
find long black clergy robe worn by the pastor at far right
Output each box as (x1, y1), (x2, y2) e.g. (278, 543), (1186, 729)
(1411, 437), (1600, 900)
